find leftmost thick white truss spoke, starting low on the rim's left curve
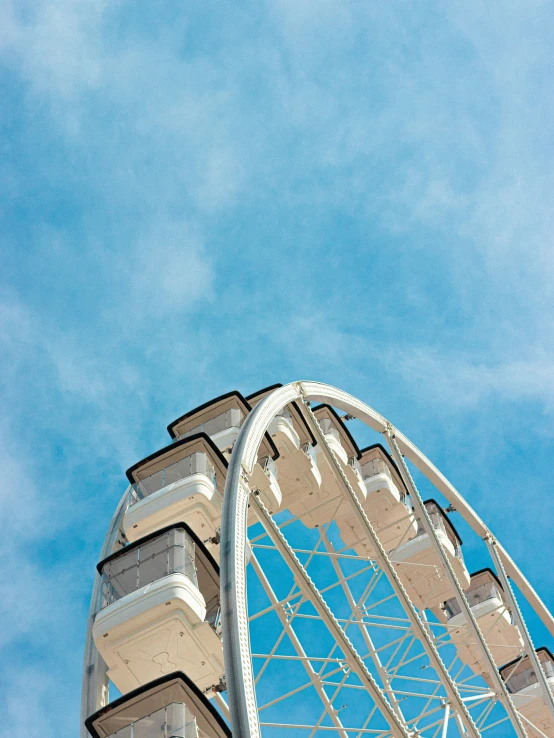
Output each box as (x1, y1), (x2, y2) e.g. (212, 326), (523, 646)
(250, 488), (410, 738)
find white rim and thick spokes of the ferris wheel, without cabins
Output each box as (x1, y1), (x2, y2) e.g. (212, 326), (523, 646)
(81, 381), (554, 738)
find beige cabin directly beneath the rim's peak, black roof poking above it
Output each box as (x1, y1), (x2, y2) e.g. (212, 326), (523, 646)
(246, 384), (321, 508)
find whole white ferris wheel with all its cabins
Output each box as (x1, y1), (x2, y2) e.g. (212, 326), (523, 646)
(81, 381), (554, 738)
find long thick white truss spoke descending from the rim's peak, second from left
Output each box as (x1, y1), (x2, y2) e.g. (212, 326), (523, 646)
(299, 402), (479, 738)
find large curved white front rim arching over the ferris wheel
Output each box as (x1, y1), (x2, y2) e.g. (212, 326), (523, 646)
(221, 381), (554, 738)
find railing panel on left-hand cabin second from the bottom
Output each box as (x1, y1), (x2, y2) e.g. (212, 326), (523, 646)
(100, 528), (198, 609)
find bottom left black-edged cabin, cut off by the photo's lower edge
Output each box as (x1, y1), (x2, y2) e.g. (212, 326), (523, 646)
(85, 671), (231, 738)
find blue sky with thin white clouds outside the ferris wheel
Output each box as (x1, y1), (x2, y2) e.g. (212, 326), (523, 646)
(0, 0), (554, 738)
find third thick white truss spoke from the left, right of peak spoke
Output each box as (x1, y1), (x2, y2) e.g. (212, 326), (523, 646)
(385, 425), (527, 738)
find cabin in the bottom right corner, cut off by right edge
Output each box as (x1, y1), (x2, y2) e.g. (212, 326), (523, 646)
(500, 648), (554, 738)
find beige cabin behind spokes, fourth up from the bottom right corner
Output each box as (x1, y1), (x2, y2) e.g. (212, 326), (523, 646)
(338, 444), (417, 558)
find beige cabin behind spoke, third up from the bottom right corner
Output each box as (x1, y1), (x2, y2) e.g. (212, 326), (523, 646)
(390, 500), (469, 610)
